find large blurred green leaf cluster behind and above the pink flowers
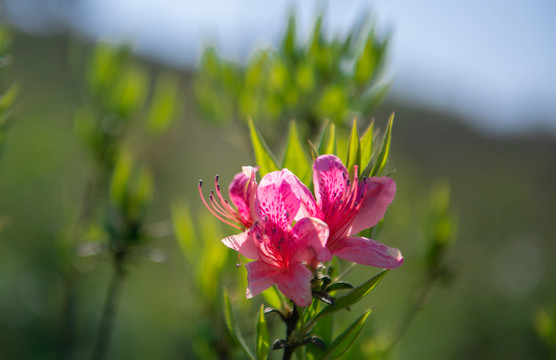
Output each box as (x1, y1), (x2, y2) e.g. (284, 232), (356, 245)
(195, 16), (390, 141)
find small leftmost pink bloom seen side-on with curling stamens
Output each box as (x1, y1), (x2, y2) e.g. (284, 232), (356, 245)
(199, 166), (257, 229)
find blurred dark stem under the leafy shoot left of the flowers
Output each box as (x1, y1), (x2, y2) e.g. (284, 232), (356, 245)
(91, 251), (125, 360)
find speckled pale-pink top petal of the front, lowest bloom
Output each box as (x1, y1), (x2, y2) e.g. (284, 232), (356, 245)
(255, 169), (299, 229)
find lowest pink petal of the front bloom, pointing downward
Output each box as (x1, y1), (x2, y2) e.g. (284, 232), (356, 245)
(276, 264), (313, 306)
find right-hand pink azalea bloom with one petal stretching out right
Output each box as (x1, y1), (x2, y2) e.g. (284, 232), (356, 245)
(298, 155), (403, 269)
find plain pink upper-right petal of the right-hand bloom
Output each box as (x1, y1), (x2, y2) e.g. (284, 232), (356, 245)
(347, 176), (396, 236)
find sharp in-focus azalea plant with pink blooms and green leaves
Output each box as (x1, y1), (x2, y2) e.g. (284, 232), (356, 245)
(199, 117), (403, 359)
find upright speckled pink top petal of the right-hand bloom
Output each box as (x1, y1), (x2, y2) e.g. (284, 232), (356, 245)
(313, 155), (349, 211)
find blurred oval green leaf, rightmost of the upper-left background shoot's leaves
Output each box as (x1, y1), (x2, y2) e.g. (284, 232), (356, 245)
(147, 73), (180, 134)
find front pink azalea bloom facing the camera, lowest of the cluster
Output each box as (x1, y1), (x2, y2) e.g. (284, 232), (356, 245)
(223, 169), (332, 306)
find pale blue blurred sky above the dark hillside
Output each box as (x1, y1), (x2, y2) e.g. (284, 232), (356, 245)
(0, 0), (556, 133)
